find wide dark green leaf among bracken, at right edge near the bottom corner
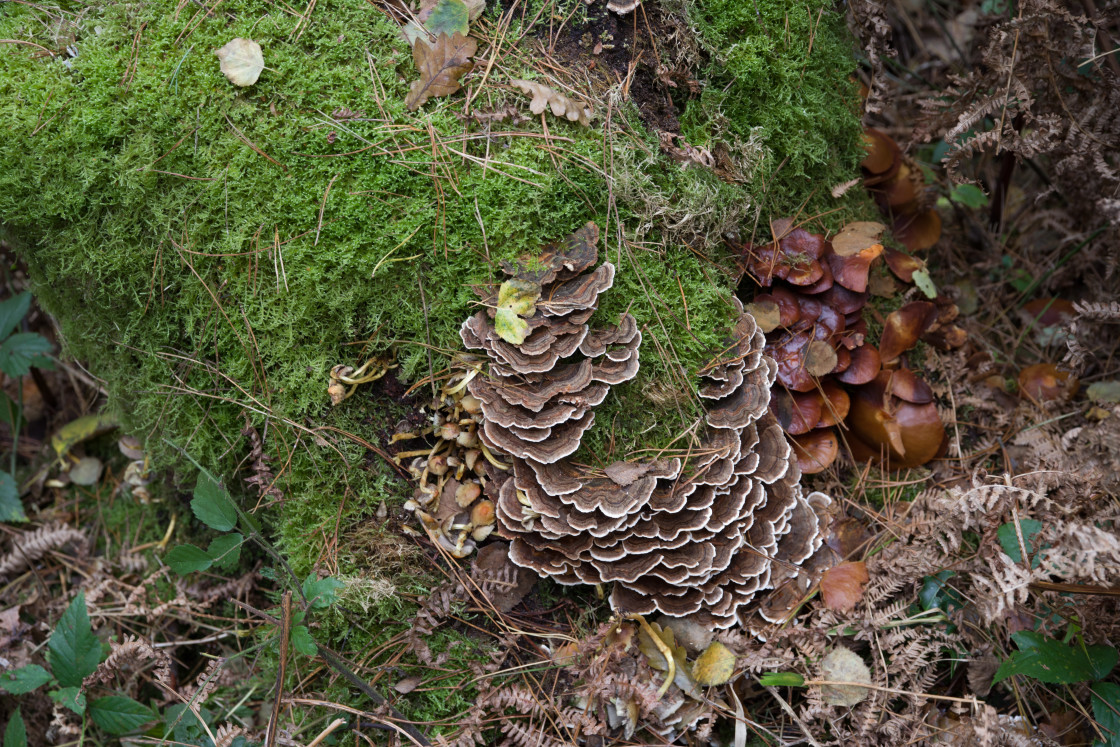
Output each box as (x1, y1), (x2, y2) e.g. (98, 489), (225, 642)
(992, 631), (1117, 684)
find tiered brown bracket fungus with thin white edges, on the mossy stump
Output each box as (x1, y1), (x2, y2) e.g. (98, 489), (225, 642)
(461, 224), (830, 627)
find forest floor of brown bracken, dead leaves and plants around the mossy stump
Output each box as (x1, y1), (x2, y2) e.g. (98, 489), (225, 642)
(0, 0), (1120, 747)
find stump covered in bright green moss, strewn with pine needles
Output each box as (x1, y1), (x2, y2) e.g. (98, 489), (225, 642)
(0, 0), (862, 572)
